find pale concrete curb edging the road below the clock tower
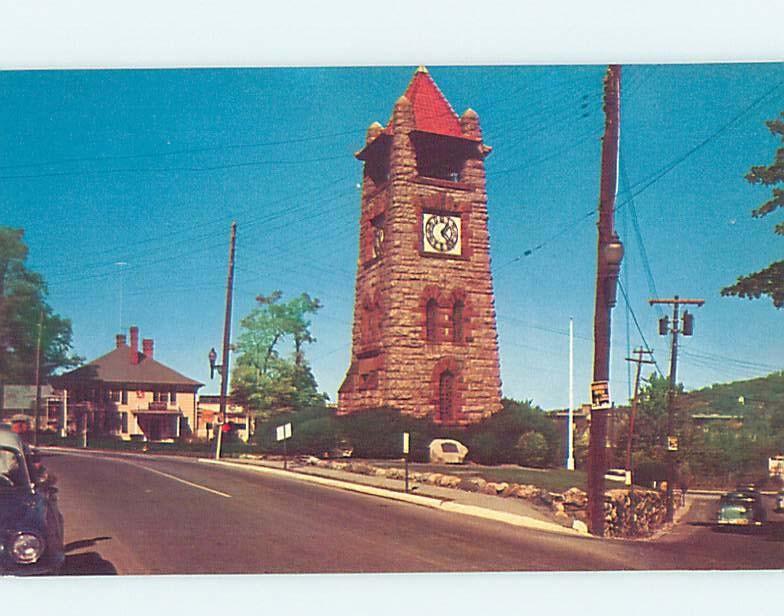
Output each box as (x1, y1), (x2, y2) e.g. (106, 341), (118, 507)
(197, 458), (584, 539)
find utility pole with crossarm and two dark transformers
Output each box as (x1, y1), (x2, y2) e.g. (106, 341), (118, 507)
(648, 295), (705, 522)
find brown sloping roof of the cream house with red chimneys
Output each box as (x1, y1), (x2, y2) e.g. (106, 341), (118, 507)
(58, 344), (204, 387)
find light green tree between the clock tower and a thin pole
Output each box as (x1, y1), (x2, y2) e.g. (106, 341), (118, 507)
(232, 291), (325, 416)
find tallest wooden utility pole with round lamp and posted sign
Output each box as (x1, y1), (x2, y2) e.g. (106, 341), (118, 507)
(588, 64), (623, 537)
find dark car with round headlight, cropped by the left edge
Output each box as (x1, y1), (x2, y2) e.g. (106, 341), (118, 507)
(0, 430), (65, 575)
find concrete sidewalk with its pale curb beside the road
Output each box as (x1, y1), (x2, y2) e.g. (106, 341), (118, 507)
(199, 458), (591, 537)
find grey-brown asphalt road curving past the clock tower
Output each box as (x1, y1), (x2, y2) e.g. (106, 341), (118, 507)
(35, 453), (784, 575)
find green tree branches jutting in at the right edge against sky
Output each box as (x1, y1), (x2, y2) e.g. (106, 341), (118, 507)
(721, 113), (784, 308)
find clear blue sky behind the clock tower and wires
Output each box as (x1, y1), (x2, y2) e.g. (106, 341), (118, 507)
(0, 64), (784, 408)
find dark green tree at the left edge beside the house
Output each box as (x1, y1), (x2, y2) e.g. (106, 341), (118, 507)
(0, 227), (82, 383)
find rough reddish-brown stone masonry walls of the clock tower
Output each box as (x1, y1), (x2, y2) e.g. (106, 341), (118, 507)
(339, 86), (501, 424)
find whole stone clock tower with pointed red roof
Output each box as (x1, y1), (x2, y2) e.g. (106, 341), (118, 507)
(338, 67), (501, 425)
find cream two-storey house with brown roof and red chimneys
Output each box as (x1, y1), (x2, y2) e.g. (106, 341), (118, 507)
(51, 327), (203, 441)
